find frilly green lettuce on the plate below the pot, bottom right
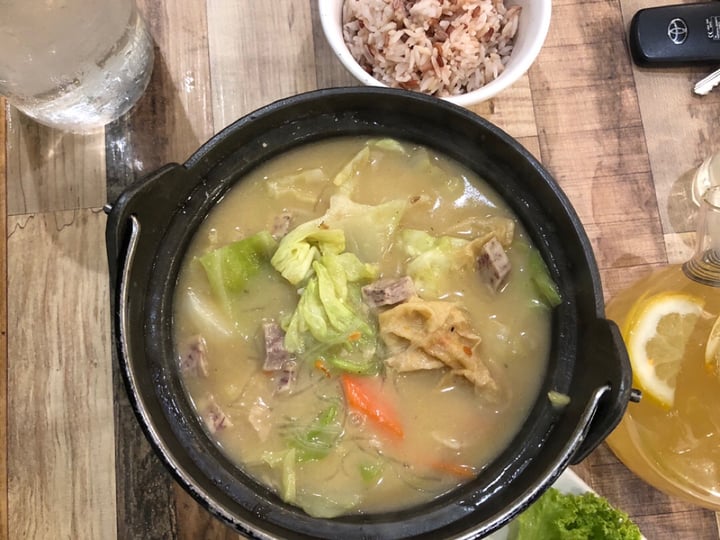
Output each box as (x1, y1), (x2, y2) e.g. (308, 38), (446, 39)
(509, 488), (642, 540)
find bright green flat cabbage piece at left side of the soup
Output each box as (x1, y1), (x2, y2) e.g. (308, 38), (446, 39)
(198, 231), (276, 312)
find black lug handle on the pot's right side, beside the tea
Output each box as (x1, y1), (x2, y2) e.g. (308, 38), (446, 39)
(570, 319), (640, 465)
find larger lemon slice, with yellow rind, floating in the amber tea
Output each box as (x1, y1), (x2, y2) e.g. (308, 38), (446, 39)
(626, 293), (704, 408)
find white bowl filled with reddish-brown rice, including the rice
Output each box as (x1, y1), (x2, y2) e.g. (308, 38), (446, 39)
(318, 0), (552, 106)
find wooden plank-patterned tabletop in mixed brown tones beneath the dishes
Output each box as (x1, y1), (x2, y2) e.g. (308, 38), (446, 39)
(0, 0), (720, 540)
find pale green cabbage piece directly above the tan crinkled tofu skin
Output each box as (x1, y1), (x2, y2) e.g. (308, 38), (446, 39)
(400, 229), (470, 298)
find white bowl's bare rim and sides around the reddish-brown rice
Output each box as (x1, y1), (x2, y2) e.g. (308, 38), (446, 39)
(318, 0), (552, 107)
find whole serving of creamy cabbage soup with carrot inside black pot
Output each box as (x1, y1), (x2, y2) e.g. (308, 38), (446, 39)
(173, 137), (560, 517)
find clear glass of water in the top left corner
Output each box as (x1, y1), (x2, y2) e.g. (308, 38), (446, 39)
(0, 0), (153, 132)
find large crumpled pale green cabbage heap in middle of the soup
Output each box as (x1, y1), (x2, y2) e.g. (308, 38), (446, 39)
(271, 195), (408, 362)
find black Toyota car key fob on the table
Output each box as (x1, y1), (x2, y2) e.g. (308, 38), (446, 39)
(628, 2), (720, 66)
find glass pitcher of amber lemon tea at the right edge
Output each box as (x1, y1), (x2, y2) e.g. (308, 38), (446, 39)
(607, 187), (720, 510)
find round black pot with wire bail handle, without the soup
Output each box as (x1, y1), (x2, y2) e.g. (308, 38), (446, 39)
(107, 88), (631, 539)
